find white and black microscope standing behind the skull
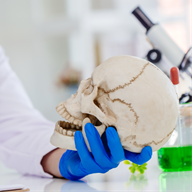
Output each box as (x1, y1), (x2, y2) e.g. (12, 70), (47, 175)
(132, 7), (192, 103)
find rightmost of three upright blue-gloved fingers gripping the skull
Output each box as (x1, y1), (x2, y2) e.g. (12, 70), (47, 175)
(106, 127), (125, 164)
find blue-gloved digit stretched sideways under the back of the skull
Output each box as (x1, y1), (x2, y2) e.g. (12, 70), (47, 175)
(124, 146), (153, 165)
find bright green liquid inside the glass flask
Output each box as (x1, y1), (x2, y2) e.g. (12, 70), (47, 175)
(157, 146), (192, 172)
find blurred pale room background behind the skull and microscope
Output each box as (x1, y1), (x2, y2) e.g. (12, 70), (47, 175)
(0, 0), (192, 121)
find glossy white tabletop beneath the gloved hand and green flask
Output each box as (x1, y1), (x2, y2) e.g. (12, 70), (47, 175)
(0, 153), (192, 192)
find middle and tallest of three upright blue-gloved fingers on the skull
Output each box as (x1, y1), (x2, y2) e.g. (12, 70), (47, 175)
(85, 123), (110, 167)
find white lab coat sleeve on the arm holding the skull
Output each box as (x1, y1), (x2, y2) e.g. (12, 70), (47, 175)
(0, 47), (55, 177)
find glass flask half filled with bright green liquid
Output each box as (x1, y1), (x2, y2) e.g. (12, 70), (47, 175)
(157, 103), (192, 172)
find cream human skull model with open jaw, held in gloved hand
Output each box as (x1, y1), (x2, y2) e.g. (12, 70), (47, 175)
(51, 56), (179, 152)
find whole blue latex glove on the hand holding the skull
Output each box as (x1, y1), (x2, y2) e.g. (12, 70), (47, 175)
(59, 123), (152, 180)
